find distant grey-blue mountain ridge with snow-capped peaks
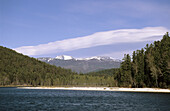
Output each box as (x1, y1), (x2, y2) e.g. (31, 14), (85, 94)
(37, 55), (121, 73)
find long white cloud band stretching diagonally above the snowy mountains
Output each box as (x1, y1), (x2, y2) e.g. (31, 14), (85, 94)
(14, 27), (169, 56)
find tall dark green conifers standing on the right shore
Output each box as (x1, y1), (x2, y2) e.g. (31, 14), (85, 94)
(115, 32), (170, 88)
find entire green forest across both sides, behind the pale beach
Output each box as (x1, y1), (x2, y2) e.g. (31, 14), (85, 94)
(0, 32), (170, 88)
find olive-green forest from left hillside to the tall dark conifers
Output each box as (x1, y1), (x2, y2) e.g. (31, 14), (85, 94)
(0, 46), (114, 86)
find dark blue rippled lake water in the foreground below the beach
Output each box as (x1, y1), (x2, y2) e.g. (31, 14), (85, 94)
(0, 88), (170, 111)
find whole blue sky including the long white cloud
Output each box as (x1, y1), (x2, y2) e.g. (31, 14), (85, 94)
(0, 0), (170, 59)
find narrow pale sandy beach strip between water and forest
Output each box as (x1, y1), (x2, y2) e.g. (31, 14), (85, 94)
(17, 87), (170, 93)
